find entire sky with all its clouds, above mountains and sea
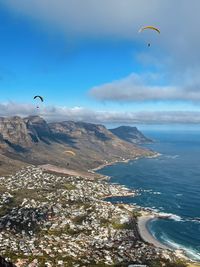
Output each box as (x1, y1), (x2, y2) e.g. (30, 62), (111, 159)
(0, 0), (200, 125)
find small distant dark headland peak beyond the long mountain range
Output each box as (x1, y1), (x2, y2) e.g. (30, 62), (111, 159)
(110, 126), (153, 144)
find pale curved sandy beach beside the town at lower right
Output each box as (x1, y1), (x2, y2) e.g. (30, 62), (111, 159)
(138, 215), (170, 249)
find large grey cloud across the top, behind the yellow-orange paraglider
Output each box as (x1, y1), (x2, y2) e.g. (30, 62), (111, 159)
(0, 0), (200, 67)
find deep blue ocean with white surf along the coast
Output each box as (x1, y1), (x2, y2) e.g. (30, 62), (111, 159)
(99, 130), (200, 261)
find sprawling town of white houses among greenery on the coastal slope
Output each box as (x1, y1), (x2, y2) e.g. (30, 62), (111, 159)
(0, 166), (184, 267)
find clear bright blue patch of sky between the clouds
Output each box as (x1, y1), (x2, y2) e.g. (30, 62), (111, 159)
(0, 6), (146, 107)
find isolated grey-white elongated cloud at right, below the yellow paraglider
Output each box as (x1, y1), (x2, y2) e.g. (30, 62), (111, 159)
(90, 73), (200, 102)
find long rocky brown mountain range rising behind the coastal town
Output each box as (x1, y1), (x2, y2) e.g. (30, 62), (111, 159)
(0, 116), (153, 174)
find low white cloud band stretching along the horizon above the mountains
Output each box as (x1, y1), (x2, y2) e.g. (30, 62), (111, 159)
(0, 102), (200, 124)
